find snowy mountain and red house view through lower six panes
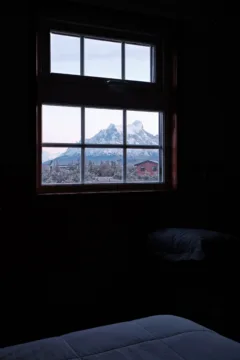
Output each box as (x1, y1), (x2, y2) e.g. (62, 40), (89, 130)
(42, 105), (163, 185)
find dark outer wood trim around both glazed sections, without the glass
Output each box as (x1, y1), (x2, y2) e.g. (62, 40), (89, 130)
(37, 16), (176, 194)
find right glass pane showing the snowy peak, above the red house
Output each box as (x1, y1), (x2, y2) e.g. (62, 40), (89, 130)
(127, 111), (159, 145)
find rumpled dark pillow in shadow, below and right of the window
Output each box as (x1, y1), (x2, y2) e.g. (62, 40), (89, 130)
(148, 228), (240, 262)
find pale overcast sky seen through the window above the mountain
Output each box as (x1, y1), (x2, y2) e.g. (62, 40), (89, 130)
(42, 34), (158, 150)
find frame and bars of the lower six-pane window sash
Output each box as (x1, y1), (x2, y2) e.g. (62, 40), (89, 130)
(37, 101), (172, 192)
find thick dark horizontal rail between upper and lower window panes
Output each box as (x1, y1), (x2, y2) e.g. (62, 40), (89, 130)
(38, 74), (169, 112)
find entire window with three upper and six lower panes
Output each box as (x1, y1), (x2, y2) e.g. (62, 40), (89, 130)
(37, 22), (175, 192)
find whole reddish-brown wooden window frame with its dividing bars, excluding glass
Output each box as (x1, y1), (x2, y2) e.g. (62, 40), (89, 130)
(36, 19), (176, 194)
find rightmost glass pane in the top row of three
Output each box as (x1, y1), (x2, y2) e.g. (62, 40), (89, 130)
(125, 44), (151, 82)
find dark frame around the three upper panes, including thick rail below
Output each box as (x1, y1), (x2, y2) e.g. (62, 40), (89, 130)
(37, 22), (171, 112)
